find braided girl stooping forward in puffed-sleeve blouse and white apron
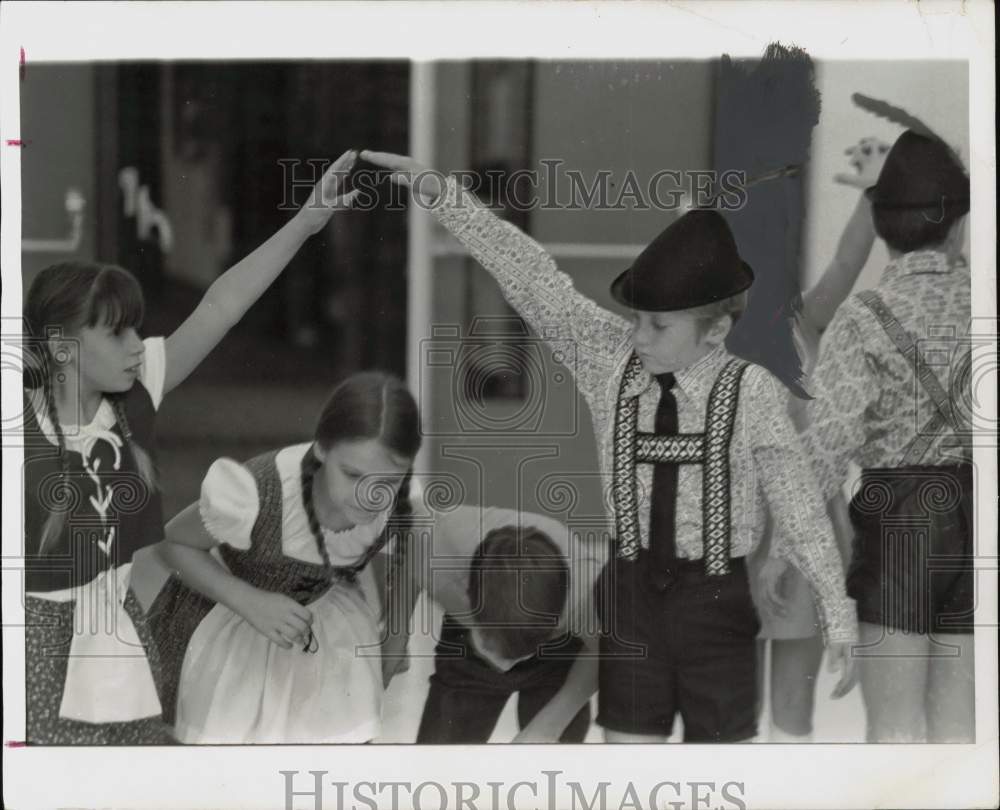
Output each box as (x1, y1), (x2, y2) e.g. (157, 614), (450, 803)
(150, 372), (421, 744)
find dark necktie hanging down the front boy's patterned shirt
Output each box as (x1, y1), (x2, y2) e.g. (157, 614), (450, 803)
(649, 373), (679, 590)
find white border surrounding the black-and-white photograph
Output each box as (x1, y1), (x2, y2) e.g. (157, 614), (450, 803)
(0, 0), (998, 810)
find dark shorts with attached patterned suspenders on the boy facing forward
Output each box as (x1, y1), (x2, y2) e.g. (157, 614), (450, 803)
(595, 358), (760, 742)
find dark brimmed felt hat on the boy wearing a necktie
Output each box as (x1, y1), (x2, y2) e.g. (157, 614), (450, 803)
(611, 209), (753, 312)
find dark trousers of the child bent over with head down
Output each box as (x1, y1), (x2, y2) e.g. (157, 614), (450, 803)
(417, 615), (590, 744)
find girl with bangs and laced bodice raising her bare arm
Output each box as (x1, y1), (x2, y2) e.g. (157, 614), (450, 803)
(24, 152), (357, 745)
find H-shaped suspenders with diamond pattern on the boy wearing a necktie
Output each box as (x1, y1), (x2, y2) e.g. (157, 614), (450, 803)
(612, 354), (749, 576)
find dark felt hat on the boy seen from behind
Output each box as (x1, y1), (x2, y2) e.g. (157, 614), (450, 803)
(865, 129), (969, 214)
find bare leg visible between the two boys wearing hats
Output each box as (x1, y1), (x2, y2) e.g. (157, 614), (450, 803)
(771, 635), (823, 737)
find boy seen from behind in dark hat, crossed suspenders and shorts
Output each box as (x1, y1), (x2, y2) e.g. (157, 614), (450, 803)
(803, 130), (975, 742)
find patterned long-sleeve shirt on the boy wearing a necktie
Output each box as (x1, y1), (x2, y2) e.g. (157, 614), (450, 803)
(434, 178), (857, 641)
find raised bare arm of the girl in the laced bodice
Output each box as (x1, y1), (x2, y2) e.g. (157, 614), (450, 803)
(163, 152), (358, 394)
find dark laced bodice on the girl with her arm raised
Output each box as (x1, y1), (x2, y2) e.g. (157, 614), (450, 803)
(24, 383), (163, 592)
